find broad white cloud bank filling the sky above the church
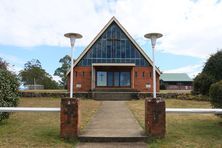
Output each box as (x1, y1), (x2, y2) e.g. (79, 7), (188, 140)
(0, 0), (222, 58)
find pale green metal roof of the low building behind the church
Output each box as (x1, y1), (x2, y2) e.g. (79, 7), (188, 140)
(160, 73), (193, 82)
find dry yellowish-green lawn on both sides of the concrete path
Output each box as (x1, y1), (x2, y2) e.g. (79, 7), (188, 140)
(0, 98), (222, 148)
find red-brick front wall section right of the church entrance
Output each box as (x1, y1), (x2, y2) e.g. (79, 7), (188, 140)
(134, 67), (160, 92)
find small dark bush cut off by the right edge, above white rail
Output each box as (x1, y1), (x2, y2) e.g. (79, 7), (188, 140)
(209, 80), (222, 108)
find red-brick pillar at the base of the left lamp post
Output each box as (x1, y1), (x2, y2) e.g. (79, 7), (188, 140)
(60, 98), (80, 139)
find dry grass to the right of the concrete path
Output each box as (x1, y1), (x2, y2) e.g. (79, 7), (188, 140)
(127, 99), (222, 148)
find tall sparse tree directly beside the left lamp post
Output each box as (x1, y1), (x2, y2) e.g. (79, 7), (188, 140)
(54, 55), (71, 88)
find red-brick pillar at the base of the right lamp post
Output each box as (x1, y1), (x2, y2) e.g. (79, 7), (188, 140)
(145, 98), (166, 138)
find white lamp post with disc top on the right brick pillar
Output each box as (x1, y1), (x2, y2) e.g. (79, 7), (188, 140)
(144, 33), (163, 99)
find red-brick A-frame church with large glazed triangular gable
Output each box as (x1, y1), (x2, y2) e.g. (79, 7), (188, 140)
(67, 17), (160, 93)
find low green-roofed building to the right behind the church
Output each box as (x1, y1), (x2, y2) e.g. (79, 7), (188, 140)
(160, 73), (193, 90)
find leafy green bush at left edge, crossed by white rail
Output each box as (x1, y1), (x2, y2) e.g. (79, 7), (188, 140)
(0, 69), (19, 121)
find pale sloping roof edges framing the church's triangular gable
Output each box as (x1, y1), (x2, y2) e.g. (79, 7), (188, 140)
(67, 16), (161, 75)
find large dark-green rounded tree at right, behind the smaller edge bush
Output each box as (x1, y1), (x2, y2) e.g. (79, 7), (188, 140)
(193, 50), (222, 95)
